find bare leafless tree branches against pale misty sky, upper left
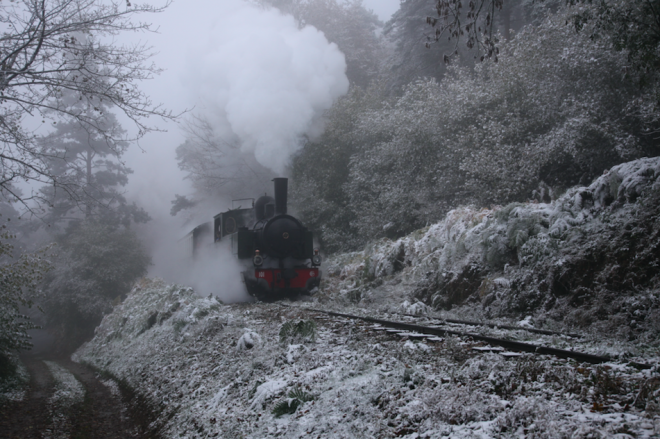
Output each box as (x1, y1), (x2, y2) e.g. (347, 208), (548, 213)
(0, 0), (176, 210)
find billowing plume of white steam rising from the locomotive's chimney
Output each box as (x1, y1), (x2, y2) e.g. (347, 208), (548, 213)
(186, 0), (348, 174)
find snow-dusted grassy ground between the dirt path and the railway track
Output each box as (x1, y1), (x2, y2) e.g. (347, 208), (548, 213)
(75, 280), (660, 439)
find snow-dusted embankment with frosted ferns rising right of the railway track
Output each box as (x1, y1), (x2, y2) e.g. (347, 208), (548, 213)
(321, 158), (660, 343)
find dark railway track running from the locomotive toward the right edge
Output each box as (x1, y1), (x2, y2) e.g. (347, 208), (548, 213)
(281, 304), (652, 369)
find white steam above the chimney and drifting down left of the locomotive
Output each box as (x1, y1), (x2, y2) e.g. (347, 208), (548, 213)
(125, 0), (360, 301)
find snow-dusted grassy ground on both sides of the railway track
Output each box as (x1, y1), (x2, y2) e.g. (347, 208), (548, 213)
(75, 159), (660, 439)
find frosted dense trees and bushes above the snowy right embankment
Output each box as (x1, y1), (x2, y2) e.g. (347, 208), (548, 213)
(293, 2), (660, 251)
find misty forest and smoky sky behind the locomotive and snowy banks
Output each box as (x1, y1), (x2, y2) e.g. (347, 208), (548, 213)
(0, 0), (660, 356)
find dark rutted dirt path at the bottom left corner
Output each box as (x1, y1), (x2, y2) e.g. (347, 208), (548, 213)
(0, 356), (158, 439)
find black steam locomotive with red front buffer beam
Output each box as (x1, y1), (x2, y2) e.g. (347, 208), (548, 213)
(192, 178), (321, 300)
